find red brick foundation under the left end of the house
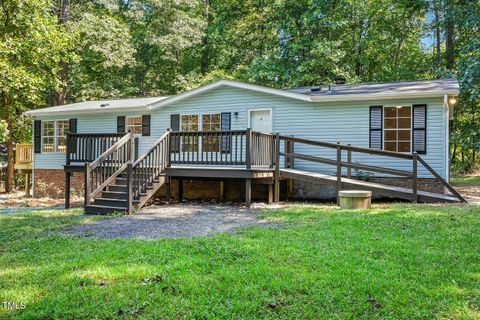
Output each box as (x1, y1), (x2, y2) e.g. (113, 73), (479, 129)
(33, 169), (84, 198)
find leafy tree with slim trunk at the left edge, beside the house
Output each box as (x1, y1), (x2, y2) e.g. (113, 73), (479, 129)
(0, 0), (72, 191)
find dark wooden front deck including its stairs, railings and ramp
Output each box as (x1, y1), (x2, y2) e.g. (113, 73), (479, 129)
(65, 129), (466, 213)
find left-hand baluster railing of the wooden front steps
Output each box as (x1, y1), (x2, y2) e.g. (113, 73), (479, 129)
(84, 132), (134, 206)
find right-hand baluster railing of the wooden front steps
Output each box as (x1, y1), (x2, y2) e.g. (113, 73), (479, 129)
(128, 129), (171, 199)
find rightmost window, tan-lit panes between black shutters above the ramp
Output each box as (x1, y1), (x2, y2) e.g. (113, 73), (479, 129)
(383, 106), (412, 152)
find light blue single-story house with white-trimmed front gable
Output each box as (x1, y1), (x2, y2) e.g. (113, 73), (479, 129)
(23, 79), (459, 211)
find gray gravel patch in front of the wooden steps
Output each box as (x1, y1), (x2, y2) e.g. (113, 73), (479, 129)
(62, 204), (278, 240)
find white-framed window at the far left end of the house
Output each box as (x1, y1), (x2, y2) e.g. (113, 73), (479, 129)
(42, 120), (70, 152)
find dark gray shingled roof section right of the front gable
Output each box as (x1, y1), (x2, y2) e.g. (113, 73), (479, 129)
(286, 78), (460, 96)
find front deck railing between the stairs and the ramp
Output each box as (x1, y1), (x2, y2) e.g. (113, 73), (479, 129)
(170, 129), (274, 169)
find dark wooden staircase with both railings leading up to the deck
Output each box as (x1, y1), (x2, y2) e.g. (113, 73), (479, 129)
(85, 131), (170, 214)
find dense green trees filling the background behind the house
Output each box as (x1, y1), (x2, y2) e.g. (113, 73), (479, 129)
(0, 0), (480, 166)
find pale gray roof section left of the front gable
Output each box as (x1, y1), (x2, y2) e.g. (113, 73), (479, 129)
(26, 96), (168, 115)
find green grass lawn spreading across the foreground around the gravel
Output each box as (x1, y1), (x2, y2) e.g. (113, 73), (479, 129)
(0, 204), (480, 319)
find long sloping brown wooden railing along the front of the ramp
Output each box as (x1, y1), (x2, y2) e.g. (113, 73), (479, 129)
(276, 135), (467, 203)
